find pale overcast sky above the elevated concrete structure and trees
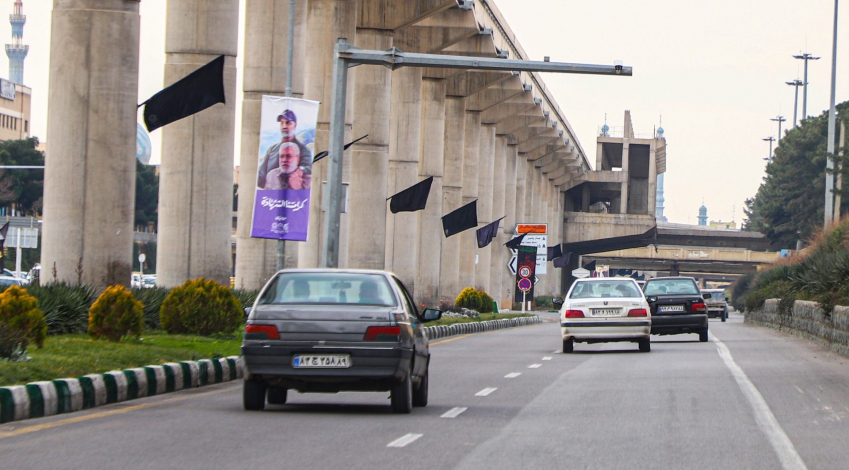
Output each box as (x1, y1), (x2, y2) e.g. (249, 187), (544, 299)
(0, 0), (849, 223)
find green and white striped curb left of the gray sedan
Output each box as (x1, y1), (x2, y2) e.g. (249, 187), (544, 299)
(0, 356), (244, 423)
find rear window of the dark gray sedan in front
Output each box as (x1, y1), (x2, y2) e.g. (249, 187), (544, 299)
(259, 273), (398, 307)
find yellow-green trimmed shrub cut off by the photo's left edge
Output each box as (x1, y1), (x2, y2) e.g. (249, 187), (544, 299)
(0, 286), (47, 359)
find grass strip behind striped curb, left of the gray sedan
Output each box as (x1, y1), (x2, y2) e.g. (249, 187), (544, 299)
(0, 331), (242, 387)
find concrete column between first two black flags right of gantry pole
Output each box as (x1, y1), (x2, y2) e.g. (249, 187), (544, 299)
(416, 78), (445, 307)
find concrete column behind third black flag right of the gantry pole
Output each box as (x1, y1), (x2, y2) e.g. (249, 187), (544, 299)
(469, 124), (495, 293)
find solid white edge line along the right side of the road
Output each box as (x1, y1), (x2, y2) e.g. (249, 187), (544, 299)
(710, 333), (808, 470)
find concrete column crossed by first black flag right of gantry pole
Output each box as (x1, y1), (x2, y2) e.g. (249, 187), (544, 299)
(386, 67), (422, 290)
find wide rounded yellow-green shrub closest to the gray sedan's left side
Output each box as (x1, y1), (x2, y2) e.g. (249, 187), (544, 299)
(159, 278), (245, 336)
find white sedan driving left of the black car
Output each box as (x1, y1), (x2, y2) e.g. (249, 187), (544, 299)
(560, 278), (651, 353)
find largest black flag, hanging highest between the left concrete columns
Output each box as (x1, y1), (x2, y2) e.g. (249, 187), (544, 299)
(139, 55), (224, 132)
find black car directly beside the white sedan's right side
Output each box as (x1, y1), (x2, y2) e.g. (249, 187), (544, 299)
(643, 277), (710, 342)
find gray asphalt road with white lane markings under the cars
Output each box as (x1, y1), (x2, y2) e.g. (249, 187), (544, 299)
(0, 308), (849, 470)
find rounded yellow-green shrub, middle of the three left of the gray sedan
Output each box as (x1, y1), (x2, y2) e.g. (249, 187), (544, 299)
(88, 286), (144, 342)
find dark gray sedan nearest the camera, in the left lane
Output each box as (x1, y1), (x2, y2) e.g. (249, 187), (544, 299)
(242, 269), (441, 413)
